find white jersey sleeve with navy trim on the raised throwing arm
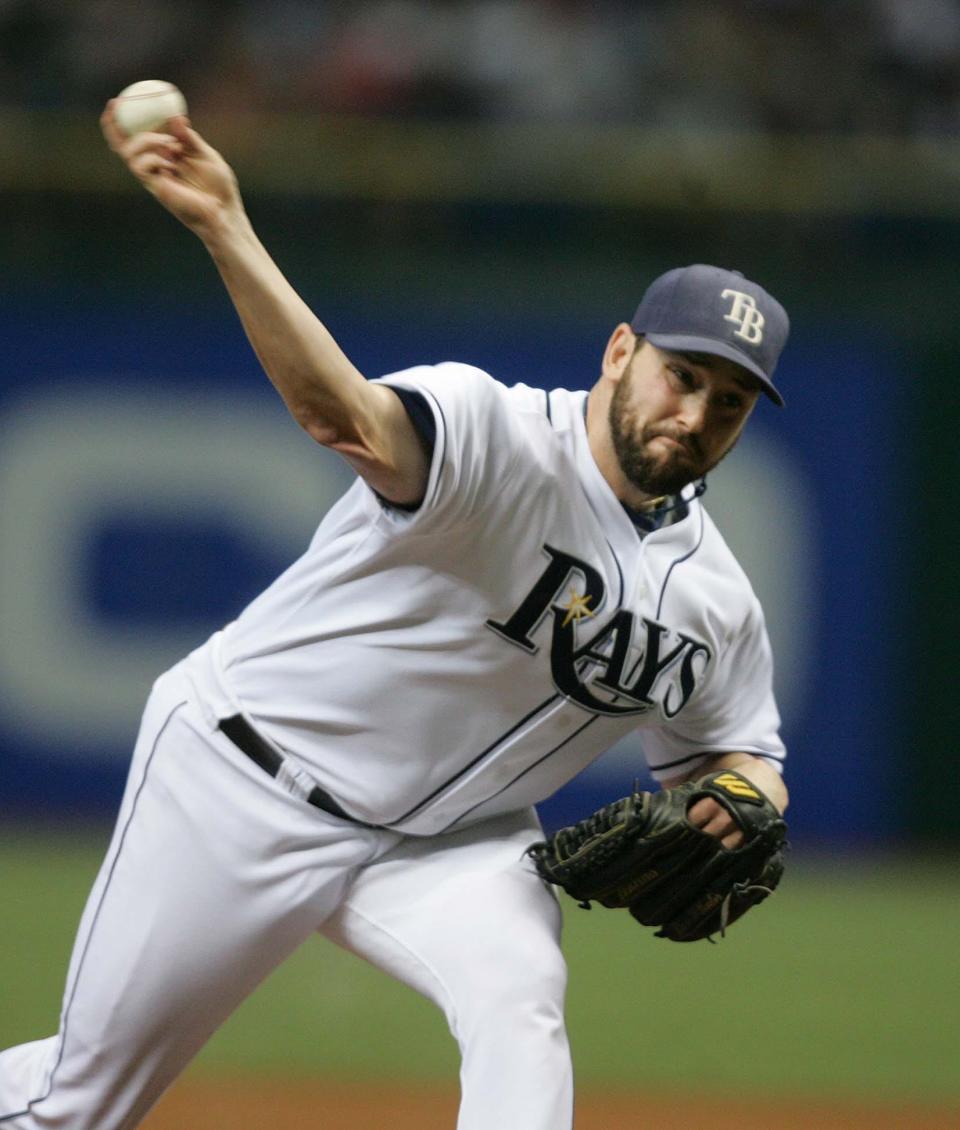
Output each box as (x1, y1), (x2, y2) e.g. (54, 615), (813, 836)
(368, 362), (523, 525)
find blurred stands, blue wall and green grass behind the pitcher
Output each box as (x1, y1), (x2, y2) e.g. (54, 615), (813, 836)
(0, 0), (960, 1130)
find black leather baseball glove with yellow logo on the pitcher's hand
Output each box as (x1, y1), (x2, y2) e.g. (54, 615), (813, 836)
(527, 770), (787, 941)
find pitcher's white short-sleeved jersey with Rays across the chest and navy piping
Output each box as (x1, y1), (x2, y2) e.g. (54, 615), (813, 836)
(186, 363), (784, 835)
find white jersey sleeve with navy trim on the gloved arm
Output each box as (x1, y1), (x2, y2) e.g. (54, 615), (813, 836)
(639, 597), (786, 781)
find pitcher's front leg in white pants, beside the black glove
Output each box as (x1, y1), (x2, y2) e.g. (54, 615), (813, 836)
(322, 815), (573, 1130)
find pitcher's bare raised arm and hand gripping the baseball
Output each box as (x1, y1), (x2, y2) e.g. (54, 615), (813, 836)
(101, 103), (428, 503)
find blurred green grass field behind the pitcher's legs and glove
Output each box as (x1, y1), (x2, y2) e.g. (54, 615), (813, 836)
(0, 829), (960, 1111)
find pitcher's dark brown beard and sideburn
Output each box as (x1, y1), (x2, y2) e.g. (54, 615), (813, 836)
(610, 380), (726, 497)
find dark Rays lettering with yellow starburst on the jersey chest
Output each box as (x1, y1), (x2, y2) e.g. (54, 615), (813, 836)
(487, 546), (713, 718)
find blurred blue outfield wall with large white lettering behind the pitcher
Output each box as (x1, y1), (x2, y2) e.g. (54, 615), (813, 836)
(0, 293), (908, 845)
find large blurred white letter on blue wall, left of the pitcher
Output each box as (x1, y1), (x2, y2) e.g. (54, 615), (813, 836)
(0, 384), (351, 758)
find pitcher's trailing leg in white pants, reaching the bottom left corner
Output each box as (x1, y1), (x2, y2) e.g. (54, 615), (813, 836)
(0, 668), (396, 1130)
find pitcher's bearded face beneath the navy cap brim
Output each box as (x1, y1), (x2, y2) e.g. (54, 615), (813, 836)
(610, 341), (759, 497)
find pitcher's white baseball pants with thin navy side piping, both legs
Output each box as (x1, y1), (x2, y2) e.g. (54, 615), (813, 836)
(0, 670), (573, 1130)
